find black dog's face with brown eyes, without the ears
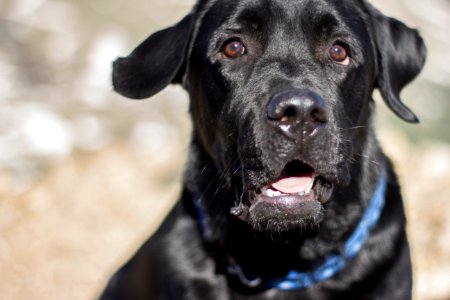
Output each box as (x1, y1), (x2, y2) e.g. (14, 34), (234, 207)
(188, 0), (375, 228)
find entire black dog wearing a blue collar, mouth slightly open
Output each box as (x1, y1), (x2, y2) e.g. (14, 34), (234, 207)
(102, 0), (426, 300)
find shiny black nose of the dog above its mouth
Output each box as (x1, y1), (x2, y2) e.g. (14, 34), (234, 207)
(267, 90), (328, 137)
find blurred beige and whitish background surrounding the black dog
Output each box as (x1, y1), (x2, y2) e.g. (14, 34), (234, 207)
(0, 0), (450, 300)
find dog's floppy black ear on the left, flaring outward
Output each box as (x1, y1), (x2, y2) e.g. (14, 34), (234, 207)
(112, 14), (194, 99)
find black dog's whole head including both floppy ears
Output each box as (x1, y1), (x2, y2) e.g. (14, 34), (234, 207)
(113, 0), (426, 230)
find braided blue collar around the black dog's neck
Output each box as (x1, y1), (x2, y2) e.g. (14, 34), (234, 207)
(196, 174), (387, 291)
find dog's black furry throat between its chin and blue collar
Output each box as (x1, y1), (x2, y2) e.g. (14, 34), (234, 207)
(183, 131), (385, 285)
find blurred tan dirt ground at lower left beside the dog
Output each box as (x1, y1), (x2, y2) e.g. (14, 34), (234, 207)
(0, 145), (185, 299)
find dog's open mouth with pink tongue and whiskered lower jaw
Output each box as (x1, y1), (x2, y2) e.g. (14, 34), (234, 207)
(236, 160), (333, 231)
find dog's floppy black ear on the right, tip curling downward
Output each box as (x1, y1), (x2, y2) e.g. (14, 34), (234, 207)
(364, 1), (426, 123)
